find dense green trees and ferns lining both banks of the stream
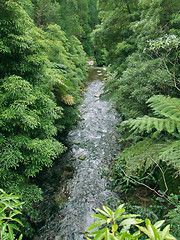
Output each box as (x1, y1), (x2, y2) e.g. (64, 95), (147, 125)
(0, 0), (180, 239)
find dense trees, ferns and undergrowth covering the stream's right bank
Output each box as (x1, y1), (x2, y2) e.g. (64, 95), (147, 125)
(92, 0), (180, 239)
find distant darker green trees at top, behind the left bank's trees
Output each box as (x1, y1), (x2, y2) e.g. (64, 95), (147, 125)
(33, 0), (98, 55)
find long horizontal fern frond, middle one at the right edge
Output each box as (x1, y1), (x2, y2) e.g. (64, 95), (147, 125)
(127, 116), (180, 133)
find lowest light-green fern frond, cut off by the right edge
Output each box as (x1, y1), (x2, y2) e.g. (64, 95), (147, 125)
(159, 140), (180, 175)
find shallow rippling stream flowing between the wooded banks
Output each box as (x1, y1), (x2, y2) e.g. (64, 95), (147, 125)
(35, 67), (118, 240)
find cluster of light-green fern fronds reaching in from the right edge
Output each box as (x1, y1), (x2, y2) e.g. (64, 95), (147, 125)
(122, 95), (180, 175)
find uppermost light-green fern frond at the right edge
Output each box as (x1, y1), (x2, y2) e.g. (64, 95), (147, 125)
(147, 95), (180, 123)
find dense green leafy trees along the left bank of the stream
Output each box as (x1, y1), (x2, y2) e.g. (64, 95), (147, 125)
(0, 0), (95, 236)
